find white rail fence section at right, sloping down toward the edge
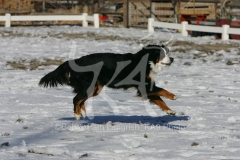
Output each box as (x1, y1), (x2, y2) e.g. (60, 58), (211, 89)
(148, 18), (240, 40)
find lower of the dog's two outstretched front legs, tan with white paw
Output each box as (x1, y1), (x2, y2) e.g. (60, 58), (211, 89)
(148, 96), (176, 115)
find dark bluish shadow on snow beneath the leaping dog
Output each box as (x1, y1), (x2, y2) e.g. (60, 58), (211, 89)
(59, 115), (190, 130)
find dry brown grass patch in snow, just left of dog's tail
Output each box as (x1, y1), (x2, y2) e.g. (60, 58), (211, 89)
(7, 59), (64, 70)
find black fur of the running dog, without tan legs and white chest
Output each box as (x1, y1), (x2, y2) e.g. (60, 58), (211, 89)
(39, 45), (173, 117)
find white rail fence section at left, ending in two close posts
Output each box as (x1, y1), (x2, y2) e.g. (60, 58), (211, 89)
(0, 13), (99, 28)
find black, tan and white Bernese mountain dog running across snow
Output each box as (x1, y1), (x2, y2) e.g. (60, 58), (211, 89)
(39, 45), (177, 120)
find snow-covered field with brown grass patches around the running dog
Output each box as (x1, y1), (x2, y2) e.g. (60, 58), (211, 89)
(0, 26), (240, 160)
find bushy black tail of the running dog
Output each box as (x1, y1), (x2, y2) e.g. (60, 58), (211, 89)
(39, 61), (71, 88)
